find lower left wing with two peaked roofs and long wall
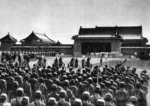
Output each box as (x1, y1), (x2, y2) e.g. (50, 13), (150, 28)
(0, 31), (73, 56)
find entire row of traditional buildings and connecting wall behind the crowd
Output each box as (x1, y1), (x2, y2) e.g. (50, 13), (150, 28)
(0, 26), (150, 57)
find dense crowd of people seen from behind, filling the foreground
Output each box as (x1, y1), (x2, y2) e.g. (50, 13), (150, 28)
(0, 55), (149, 106)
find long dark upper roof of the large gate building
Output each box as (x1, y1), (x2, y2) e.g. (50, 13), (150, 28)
(79, 26), (142, 36)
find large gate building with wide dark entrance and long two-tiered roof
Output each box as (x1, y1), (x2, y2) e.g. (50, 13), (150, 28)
(72, 26), (150, 57)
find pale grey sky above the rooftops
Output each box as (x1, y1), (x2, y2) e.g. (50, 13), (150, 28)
(0, 0), (150, 43)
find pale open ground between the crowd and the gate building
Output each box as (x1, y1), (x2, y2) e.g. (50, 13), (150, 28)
(30, 57), (150, 75)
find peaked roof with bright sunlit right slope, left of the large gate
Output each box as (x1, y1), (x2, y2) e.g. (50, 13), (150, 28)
(21, 32), (55, 43)
